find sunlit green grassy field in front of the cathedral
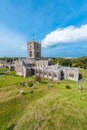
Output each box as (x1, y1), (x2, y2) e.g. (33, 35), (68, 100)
(0, 70), (87, 130)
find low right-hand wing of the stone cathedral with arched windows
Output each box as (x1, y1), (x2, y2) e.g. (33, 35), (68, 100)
(35, 65), (79, 81)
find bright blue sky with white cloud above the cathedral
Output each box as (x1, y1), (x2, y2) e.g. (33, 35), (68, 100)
(0, 0), (87, 57)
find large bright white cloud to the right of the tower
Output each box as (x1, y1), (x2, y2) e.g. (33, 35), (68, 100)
(42, 24), (87, 47)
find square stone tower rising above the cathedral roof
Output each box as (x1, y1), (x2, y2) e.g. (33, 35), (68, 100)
(27, 41), (41, 60)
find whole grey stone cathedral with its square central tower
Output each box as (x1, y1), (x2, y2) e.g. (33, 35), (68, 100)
(15, 41), (79, 81)
